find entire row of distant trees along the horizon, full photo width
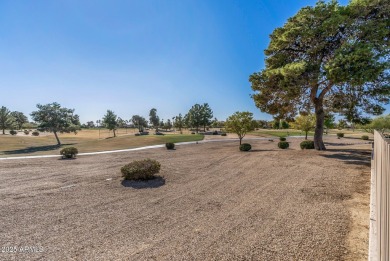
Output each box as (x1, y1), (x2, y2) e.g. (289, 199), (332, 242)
(0, 102), (390, 145)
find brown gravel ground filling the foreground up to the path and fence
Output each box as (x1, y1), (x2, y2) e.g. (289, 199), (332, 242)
(0, 138), (370, 261)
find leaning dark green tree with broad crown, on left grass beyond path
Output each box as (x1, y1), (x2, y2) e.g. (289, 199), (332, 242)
(31, 102), (80, 145)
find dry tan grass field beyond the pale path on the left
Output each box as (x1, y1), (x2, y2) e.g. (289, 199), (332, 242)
(0, 134), (203, 157)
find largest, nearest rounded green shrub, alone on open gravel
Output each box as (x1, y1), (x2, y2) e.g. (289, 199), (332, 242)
(121, 159), (161, 180)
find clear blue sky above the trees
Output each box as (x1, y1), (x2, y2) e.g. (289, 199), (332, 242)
(0, 0), (384, 122)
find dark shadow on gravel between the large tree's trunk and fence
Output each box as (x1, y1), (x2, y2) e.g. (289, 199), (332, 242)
(322, 149), (371, 167)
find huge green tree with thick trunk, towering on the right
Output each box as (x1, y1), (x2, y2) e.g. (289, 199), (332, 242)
(249, 0), (390, 150)
